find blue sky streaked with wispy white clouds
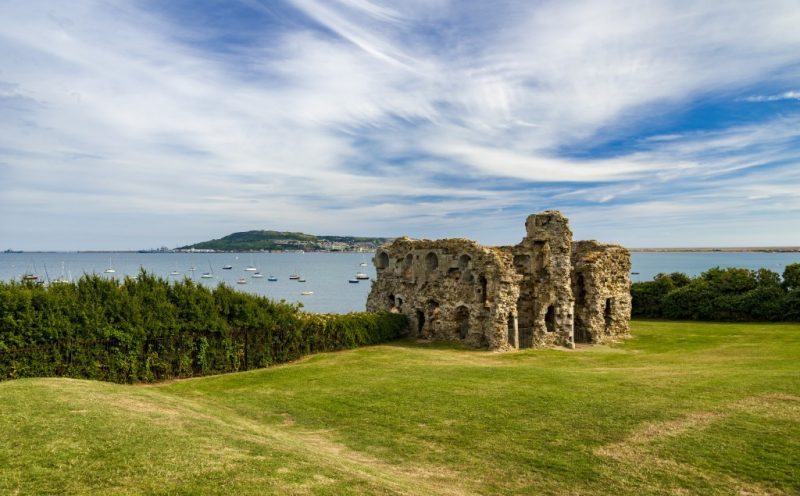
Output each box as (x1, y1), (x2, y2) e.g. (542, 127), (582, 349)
(0, 0), (800, 250)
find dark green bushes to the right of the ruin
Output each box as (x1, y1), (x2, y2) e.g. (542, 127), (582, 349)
(631, 263), (800, 321)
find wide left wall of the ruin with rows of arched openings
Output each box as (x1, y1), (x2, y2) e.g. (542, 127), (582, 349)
(367, 238), (520, 349)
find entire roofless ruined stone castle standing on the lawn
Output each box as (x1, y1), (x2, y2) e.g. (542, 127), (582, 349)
(367, 210), (631, 350)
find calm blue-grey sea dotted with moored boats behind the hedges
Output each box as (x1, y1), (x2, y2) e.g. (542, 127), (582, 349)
(0, 252), (800, 313)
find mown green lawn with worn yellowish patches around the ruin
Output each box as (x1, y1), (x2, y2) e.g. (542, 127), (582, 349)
(0, 321), (800, 495)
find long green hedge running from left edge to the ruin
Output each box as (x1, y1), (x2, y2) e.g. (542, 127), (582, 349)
(0, 272), (407, 383)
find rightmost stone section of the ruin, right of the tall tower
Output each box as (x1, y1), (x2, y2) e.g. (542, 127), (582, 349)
(572, 241), (631, 343)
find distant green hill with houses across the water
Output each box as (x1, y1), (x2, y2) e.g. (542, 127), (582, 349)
(178, 231), (392, 251)
